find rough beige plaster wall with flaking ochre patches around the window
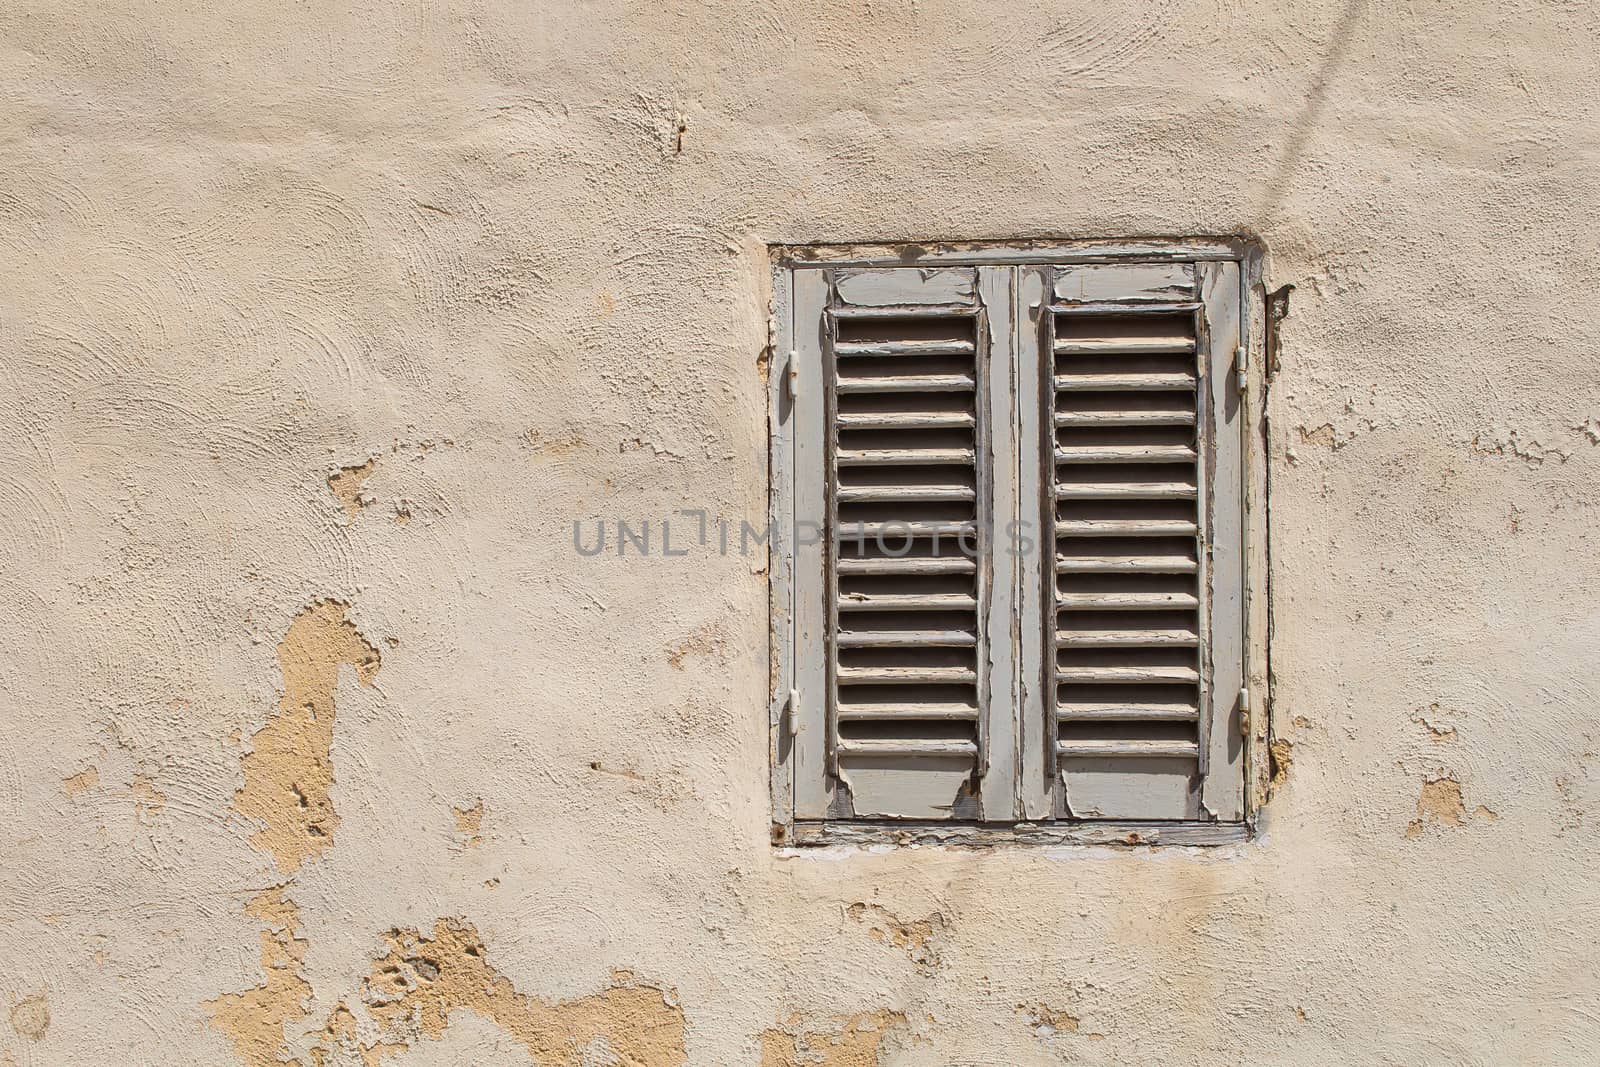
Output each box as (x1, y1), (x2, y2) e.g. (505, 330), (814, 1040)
(0, 0), (1600, 1067)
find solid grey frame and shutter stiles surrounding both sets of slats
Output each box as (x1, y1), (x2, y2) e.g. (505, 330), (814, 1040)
(768, 242), (1267, 843)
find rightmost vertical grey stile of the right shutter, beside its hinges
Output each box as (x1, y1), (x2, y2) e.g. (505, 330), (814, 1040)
(1200, 262), (1245, 822)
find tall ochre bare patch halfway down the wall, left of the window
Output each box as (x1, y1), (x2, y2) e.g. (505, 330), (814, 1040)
(234, 600), (381, 873)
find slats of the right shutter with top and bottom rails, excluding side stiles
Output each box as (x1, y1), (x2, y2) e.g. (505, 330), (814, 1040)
(1043, 264), (1206, 819)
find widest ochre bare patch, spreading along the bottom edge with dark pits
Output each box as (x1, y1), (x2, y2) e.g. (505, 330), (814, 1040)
(310, 918), (688, 1067)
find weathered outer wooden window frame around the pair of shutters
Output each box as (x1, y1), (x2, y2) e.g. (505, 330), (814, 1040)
(766, 238), (1270, 845)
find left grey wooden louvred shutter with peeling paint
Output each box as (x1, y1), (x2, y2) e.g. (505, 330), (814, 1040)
(795, 267), (1013, 819)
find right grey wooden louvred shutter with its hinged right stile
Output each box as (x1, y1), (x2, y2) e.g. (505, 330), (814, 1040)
(1040, 264), (1243, 821)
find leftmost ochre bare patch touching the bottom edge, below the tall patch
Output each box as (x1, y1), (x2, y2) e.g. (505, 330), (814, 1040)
(203, 888), (310, 1067)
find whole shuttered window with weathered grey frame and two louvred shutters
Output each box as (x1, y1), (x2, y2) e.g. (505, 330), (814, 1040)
(771, 242), (1254, 841)
